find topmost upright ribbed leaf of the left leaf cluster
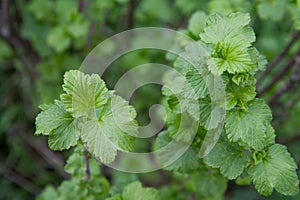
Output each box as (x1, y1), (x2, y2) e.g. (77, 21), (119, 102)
(61, 70), (108, 118)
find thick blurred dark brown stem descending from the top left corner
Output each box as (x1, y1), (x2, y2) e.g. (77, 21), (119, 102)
(0, 0), (39, 119)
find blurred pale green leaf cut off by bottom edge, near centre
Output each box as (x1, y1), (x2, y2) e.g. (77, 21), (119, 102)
(122, 181), (160, 200)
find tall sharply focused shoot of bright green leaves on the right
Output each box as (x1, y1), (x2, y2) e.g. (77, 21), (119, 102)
(200, 13), (299, 195)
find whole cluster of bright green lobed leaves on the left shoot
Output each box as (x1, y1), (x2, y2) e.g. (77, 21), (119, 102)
(36, 70), (138, 163)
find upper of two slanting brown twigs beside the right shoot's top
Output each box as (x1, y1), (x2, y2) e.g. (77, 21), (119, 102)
(257, 32), (300, 85)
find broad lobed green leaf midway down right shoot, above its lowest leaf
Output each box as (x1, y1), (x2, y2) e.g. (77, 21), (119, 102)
(225, 99), (272, 150)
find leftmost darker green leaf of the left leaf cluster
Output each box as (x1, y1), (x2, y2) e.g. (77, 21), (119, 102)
(35, 101), (80, 150)
